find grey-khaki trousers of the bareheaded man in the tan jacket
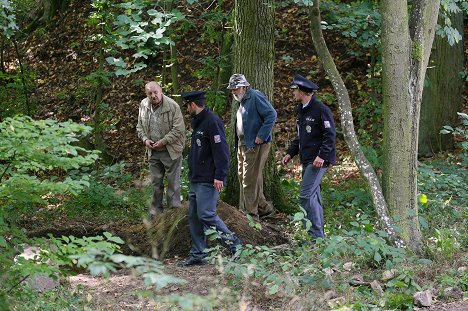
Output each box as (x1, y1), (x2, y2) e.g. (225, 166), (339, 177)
(149, 150), (182, 216)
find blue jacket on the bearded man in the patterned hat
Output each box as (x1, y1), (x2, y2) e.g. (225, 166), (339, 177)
(234, 88), (276, 148)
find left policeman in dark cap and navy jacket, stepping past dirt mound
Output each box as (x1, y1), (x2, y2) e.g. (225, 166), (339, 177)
(181, 91), (241, 266)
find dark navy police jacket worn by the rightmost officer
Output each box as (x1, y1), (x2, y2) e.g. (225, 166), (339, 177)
(287, 96), (336, 165)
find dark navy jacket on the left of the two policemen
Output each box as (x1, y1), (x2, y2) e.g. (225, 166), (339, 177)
(188, 107), (229, 183)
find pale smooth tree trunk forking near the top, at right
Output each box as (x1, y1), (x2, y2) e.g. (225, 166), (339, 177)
(381, 0), (440, 255)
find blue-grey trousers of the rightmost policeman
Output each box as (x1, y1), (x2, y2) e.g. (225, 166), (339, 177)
(299, 163), (327, 238)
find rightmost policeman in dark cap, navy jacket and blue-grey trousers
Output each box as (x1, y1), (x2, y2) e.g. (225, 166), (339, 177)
(283, 75), (336, 239)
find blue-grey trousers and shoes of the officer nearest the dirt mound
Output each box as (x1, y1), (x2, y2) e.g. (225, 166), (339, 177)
(189, 182), (241, 259)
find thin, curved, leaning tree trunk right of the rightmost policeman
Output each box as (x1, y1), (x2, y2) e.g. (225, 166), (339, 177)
(310, 0), (403, 246)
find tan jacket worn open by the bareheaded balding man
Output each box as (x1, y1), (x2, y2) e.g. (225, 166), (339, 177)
(136, 95), (185, 160)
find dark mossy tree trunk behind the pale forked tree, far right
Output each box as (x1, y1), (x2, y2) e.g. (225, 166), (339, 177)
(418, 12), (464, 156)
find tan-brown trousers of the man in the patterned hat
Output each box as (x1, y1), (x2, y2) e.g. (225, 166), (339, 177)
(237, 143), (273, 218)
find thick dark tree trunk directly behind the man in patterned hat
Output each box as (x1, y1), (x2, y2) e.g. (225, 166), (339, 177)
(224, 0), (288, 211)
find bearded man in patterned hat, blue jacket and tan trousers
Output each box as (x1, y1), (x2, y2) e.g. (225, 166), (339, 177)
(227, 73), (276, 219)
